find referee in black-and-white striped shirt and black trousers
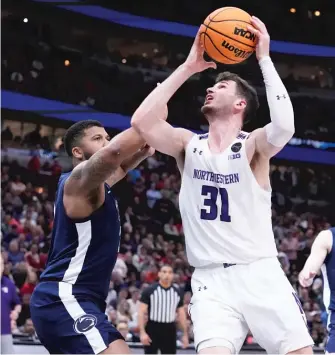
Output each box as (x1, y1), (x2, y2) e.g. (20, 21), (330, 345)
(138, 265), (188, 354)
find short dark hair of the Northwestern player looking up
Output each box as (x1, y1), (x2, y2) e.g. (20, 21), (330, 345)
(215, 71), (259, 122)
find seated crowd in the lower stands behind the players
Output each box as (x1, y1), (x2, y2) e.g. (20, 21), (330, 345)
(1, 139), (334, 345)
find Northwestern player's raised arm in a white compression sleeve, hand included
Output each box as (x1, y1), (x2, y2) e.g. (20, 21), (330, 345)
(248, 16), (294, 158)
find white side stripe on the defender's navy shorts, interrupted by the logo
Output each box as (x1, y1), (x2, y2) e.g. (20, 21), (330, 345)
(58, 282), (107, 354)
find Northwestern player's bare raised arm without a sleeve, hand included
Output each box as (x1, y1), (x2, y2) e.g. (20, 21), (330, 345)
(131, 29), (216, 158)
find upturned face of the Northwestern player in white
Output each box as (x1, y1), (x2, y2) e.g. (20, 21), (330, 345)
(201, 80), (244, 115)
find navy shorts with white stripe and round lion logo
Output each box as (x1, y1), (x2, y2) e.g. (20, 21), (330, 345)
(30, 282), (123, 354)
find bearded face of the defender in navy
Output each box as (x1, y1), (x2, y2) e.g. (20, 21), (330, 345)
(74, 127), (111, 160)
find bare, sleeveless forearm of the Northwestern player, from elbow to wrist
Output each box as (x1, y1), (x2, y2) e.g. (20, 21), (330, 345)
(131, 64), (194, 131)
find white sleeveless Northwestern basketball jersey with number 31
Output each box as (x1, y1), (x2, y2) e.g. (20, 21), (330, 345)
(179, 132), (277, 267)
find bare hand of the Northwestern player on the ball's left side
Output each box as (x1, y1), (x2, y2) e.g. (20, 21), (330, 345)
(184, 30), (216, 74)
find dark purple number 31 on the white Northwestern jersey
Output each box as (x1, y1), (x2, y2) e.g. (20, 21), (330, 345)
(200, 185), (231, 222)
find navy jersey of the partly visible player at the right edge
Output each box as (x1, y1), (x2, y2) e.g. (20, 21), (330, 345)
(321, 228), (335, 311)
